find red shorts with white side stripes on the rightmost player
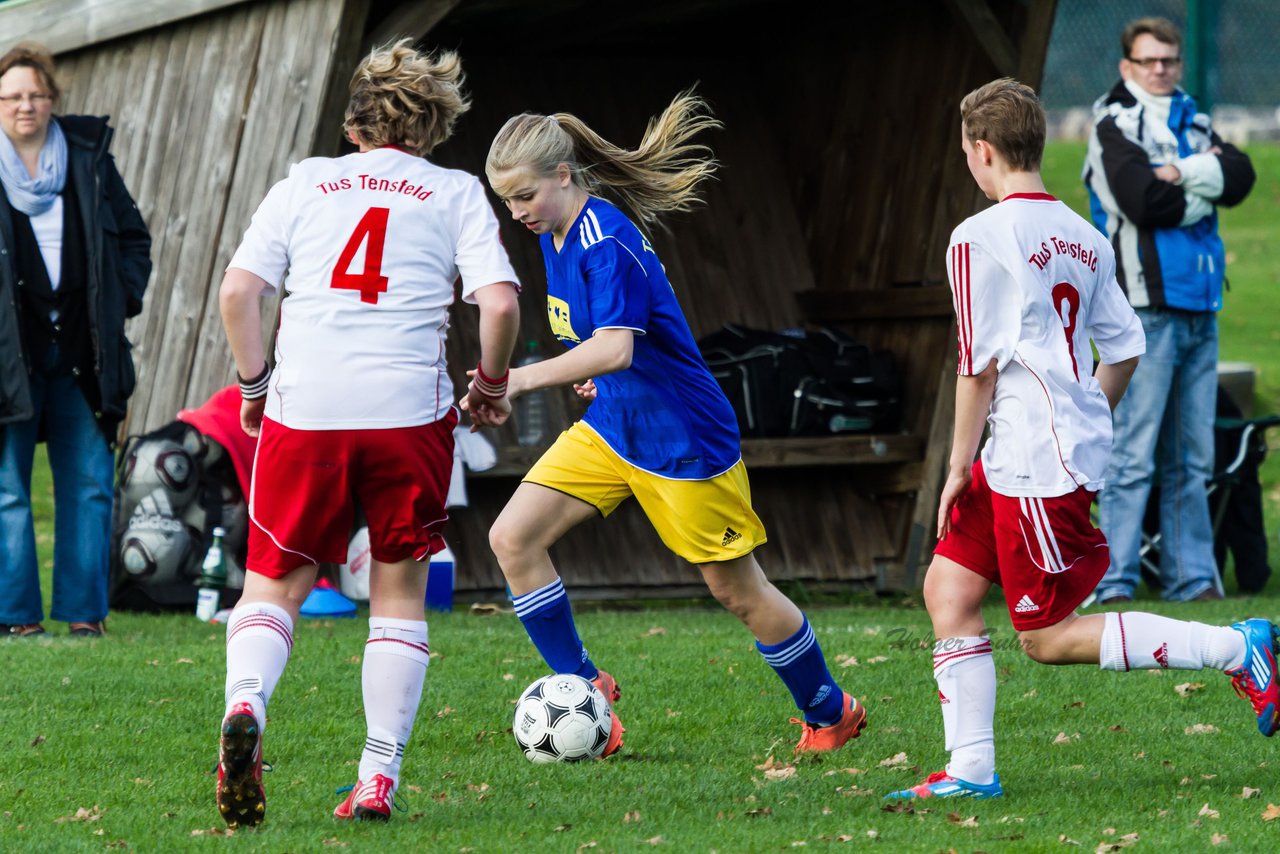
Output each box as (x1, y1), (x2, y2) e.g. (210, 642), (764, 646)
(933, 460), (1111, 631)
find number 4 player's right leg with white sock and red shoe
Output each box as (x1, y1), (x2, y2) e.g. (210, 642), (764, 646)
(333, 558), (431, 821)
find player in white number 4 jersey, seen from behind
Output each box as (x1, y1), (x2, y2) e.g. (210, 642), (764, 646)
(216, 41), (520, 827)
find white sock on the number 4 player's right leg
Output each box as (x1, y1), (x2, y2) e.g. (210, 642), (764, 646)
(360, 617), (431, 785)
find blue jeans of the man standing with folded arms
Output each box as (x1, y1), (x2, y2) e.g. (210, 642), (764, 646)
(1097, 309), (1220, 602)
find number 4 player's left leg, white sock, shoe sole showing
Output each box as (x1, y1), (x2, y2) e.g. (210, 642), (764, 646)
(216, 565), (319, 827)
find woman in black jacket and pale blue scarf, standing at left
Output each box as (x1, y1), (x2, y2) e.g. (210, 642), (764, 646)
(0, 45), (151, 636)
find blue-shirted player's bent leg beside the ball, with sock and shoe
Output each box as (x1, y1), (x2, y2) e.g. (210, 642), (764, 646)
(489, 483), (626, 757)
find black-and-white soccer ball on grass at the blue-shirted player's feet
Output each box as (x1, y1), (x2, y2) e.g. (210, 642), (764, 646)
(511, 673), (612, 764)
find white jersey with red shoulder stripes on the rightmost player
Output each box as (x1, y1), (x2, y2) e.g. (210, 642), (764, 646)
(947, 193), (1146, 498)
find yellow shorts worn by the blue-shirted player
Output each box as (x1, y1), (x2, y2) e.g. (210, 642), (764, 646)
(524, 421), (767, 563)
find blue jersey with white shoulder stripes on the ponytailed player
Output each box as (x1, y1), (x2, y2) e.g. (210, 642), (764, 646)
(541, 197), (741, 480)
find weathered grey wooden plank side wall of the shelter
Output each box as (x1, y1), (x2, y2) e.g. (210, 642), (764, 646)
(51, 0), (367, 433)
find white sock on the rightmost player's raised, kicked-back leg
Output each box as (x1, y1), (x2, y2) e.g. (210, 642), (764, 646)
(1098, 611), (1244, 671)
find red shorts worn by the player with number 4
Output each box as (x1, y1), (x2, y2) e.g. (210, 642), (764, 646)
(246, 410), (458, 579)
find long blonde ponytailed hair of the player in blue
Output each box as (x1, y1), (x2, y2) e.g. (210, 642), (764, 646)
(485, 90), (723, 225)
